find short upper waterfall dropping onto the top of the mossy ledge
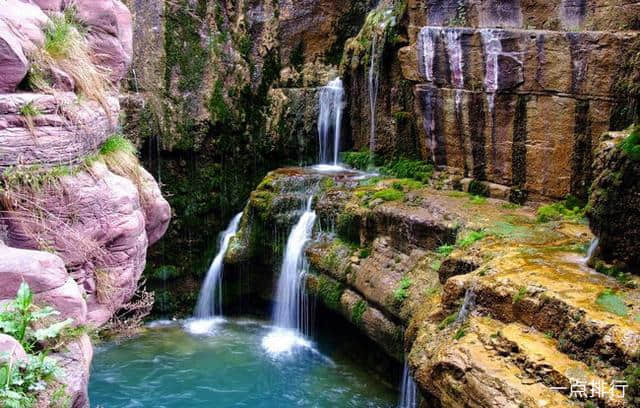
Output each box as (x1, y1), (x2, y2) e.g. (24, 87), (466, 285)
(318, 78), (344, 166)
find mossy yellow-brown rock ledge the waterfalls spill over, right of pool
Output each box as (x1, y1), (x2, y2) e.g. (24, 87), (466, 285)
(225, 165), (640, 407)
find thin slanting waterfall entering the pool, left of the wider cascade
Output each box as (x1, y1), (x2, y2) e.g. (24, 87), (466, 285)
(195, 213), (242, 319)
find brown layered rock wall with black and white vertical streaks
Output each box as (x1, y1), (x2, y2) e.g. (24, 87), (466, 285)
(380, 1), (640, 199)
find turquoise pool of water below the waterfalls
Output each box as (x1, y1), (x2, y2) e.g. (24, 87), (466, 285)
(89, 320), (397, 408)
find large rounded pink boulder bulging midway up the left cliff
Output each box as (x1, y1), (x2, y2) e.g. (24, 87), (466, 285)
(5, 162), (150, 326)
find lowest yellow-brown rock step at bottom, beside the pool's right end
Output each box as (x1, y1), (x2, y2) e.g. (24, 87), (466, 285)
(409, 317), (579, 408)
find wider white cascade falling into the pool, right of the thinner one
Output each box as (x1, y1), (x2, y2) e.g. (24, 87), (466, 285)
(262, 197), (316, 354)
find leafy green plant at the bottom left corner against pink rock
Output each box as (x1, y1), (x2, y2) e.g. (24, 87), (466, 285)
(0, 282), (77, 408)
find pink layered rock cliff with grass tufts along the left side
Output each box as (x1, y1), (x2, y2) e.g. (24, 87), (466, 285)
(0, 0), (171, 407)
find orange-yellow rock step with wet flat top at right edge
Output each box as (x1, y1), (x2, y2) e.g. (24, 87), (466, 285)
(443, 250), (640, 372)
